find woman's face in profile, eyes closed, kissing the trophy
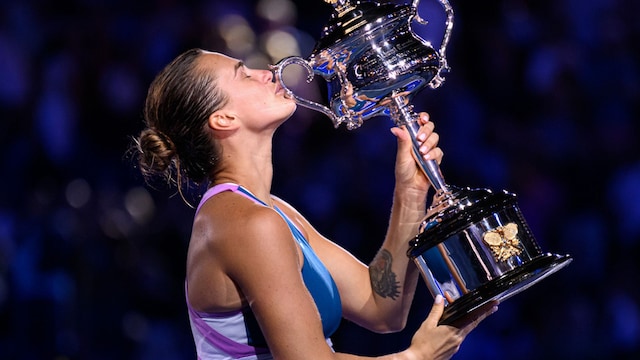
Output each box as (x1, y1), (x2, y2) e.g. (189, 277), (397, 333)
(200, 53), (296, 127)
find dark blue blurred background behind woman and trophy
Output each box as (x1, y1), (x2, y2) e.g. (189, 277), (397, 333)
(0, 0), (640, 360)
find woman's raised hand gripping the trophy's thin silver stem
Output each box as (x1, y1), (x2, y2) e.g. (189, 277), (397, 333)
(391, 112), (443, 195)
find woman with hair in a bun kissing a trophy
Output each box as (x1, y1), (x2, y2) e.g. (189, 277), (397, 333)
(136, 49), (498, 360)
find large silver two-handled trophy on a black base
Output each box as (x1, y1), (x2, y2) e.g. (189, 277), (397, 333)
(271, 0), (572, 325)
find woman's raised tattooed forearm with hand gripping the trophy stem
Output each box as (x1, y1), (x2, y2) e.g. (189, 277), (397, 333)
(362, 113), (442, 331)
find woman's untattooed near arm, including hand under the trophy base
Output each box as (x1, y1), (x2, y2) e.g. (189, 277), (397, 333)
(219, 202), (490, 360)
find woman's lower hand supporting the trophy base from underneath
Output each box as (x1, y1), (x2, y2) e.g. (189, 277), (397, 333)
(405, 295), (498, 360)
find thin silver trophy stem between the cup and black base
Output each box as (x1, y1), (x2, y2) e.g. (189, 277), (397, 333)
(389, 95), (450, 195)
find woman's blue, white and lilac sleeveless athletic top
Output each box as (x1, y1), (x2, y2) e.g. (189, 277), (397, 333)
(185, 183), (342, 360)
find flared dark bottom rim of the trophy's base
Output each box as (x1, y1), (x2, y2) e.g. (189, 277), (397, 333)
(439, 254), (573, 326)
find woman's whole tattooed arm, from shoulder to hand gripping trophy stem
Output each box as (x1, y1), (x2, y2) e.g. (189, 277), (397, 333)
(283, 113), (442, 332)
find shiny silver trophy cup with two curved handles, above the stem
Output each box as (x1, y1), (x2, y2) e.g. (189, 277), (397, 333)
(272, 0), (453, 129)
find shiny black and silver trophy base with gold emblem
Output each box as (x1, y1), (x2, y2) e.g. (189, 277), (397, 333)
(407, 188), (573, 326)
